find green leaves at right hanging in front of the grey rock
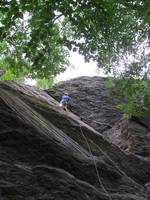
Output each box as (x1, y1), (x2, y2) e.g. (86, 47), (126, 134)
(107, 78), (150, 117)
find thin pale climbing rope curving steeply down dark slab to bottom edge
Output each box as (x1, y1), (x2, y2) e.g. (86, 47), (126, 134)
(79, 124), (113, 200)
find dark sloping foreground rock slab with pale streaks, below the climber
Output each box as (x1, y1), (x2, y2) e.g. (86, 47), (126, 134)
(0, 82), (150, 200)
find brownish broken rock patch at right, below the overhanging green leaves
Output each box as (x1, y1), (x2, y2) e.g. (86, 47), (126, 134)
(105, 119), (150, 159)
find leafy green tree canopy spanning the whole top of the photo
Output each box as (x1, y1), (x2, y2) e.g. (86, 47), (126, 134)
(0, 0), (150, 116)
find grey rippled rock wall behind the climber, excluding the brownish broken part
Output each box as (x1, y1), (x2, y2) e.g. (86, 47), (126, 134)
(49, 77), (122, 133)
